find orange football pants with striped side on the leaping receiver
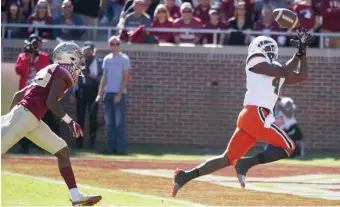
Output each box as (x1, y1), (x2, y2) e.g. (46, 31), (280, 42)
(226, 106), (295, 164)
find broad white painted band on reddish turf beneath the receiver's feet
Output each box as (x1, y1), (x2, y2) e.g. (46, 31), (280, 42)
(121, 169), (340, 200)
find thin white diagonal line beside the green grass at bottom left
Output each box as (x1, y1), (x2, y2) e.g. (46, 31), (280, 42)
(1, 171), (208, 207)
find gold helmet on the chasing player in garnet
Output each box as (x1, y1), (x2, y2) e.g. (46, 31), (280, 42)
(53, 42), (85, 78)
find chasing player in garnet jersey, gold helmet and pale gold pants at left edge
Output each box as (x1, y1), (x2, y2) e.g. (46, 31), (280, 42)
(1, 42), (102, 205)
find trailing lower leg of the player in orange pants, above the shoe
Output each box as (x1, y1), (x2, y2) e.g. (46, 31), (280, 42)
(186, 155), (230, 179)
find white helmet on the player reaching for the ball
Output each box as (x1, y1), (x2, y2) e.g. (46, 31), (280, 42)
(248, 36), (279, 61)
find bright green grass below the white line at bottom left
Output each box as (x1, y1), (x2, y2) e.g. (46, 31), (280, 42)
(1, 173), (189, 206)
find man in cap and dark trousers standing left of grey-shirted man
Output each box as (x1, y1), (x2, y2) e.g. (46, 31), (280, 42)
(70, 41), (103, 149)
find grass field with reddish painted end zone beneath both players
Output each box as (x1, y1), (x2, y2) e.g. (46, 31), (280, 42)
(1, 145), (340, 206)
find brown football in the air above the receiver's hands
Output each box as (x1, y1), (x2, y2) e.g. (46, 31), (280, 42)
(273, 8), (300, 29)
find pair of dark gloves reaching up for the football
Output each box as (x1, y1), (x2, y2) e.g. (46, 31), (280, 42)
(290, 29), (315, 58)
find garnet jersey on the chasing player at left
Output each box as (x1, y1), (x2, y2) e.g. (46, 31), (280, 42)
(18, 63), (74, 120)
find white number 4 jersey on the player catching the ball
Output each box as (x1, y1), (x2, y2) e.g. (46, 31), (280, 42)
(244, 52), (285, 111)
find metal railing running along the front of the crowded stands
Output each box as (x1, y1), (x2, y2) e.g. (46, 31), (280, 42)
(1, 23), (340, 48)
